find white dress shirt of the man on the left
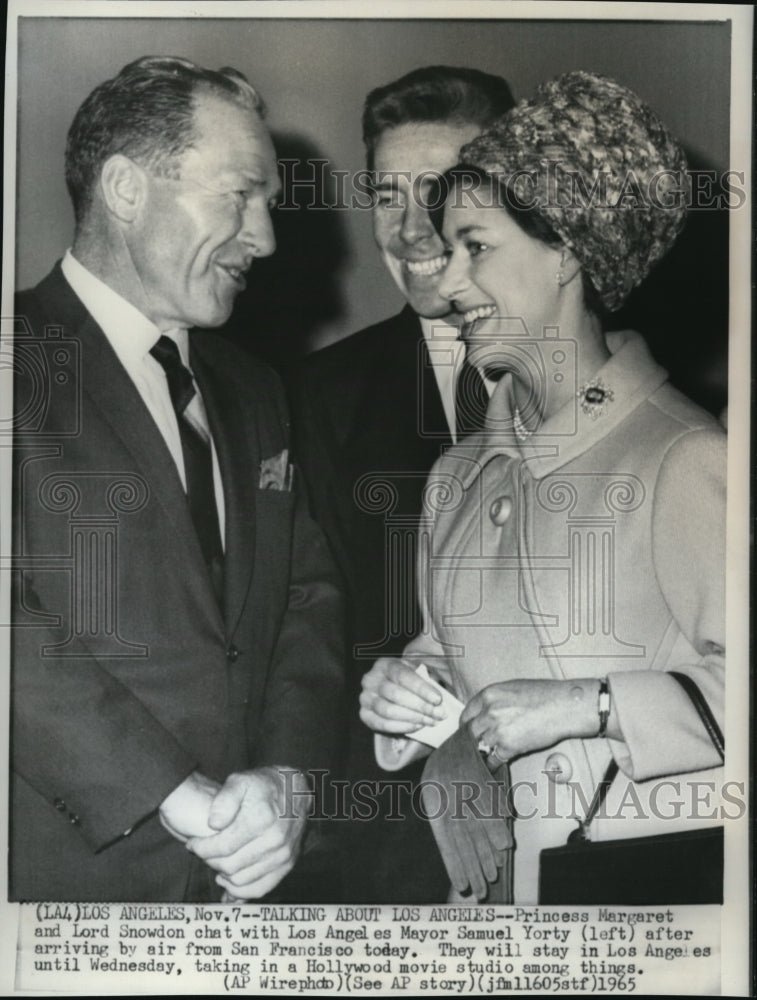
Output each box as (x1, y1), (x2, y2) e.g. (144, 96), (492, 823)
(61, 250), (226, 544)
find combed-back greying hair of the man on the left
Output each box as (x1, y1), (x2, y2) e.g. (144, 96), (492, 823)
(66, 56), (265, 226)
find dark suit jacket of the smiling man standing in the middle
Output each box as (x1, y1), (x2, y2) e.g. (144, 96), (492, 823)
(288, 307), (452, 903)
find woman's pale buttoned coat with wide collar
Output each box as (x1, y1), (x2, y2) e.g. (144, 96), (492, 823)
(376, 332), (726, 903)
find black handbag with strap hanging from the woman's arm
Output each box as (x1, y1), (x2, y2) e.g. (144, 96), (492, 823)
(539, 672), (725, 906)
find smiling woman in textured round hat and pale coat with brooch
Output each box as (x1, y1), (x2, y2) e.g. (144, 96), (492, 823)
(361, 72), (726, 903)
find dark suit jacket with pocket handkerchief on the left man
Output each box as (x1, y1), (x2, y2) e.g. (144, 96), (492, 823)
(10, 267), (342, 900)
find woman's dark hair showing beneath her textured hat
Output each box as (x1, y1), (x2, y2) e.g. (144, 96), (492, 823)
(438, 163), (607, 319)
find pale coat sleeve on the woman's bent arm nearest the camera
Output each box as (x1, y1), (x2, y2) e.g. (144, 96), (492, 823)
(608, 429), (726, 781)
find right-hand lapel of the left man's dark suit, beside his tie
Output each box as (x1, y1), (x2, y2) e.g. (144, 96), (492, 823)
(190, 332), (260, 635)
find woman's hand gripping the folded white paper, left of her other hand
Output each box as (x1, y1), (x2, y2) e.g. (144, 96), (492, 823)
(360, 656), (446, 736)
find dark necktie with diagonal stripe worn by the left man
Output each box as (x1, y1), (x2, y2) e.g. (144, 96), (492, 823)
(150, 336), (223, 604)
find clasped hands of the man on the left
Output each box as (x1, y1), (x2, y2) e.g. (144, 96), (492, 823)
(159, 767), (311, 899)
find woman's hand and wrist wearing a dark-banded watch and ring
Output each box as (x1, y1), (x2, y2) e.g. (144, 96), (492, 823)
(460, 679), (599, 761)
